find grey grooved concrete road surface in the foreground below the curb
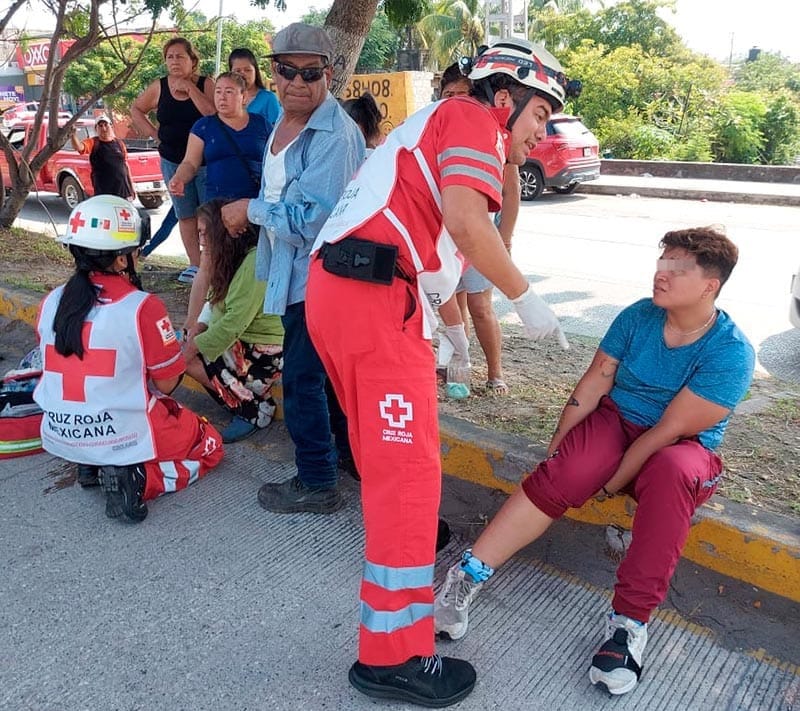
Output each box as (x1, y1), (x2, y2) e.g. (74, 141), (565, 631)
(0, 406), (800, 711)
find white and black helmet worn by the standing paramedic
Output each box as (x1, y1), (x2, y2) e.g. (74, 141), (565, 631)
(469, 37), (567, 111)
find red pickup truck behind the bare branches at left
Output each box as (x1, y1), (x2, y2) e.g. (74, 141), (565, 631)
(0, 119), (167, 210)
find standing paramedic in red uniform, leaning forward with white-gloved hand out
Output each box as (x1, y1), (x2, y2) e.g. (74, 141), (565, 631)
(306, 39), (567, 706)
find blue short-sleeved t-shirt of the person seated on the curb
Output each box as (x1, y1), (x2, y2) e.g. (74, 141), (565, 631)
(600, 299), (755, 450)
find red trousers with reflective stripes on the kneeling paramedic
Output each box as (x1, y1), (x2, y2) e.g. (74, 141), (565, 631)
(144, 397), (223, 500)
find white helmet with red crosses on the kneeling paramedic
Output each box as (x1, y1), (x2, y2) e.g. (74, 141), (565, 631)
(59, 195), (142, 254)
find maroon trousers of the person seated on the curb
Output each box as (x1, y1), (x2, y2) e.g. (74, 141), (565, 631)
(522, 397), (722, 622)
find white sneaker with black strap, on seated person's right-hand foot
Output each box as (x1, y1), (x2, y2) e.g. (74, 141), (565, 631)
(589, 612), (647, 695)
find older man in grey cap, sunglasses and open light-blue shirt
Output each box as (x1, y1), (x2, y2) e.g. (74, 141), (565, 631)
(222, 22), (365, 513)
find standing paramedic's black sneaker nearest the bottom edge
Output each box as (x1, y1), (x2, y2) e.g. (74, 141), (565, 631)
(348, 654), (475, 708)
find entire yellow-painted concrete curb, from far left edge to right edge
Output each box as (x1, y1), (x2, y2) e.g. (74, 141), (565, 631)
(0, 286), (800, 602)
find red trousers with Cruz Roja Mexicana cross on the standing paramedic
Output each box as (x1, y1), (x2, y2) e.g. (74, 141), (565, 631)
(306, 259), (441, 665)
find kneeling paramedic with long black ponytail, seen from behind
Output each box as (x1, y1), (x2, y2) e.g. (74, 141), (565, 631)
(34, 195), (222, 522)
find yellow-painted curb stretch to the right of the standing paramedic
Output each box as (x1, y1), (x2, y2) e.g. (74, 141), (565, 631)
(441, 418), (800, 602)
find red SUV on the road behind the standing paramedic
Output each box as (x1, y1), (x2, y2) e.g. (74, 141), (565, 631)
(519, 114), (600, 200)
